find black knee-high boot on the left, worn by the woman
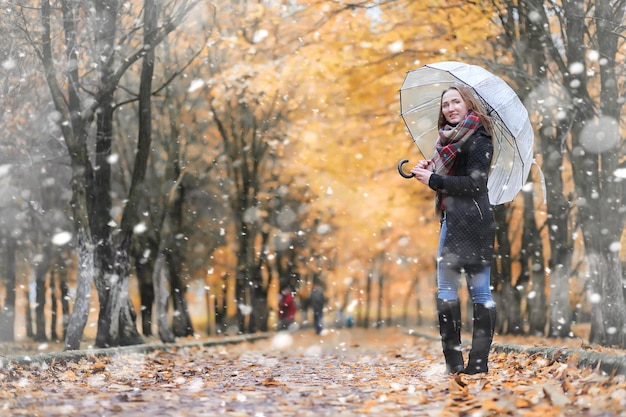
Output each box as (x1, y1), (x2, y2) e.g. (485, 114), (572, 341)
(437, 298), (463, 374)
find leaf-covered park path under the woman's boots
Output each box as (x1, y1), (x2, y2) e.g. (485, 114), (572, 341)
(0, 328), (626, 417)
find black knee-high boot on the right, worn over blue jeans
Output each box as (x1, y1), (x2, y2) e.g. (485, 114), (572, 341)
(462, 304), (496, 375)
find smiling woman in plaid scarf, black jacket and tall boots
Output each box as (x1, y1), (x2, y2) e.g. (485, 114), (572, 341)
(411, 86), (496, 374)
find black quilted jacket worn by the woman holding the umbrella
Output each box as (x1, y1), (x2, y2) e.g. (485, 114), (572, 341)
(428, 127), (495, 270)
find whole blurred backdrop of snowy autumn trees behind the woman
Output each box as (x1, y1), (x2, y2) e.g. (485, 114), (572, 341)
(0, 0), (625, 348)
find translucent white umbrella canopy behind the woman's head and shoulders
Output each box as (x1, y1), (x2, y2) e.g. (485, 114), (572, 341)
(398, 61), (534, 205)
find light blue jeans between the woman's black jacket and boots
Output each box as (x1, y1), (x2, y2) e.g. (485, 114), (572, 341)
(437, 217), (495, 307)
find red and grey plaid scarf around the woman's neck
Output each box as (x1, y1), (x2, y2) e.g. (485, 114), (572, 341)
(433, 110), (481, 175)
